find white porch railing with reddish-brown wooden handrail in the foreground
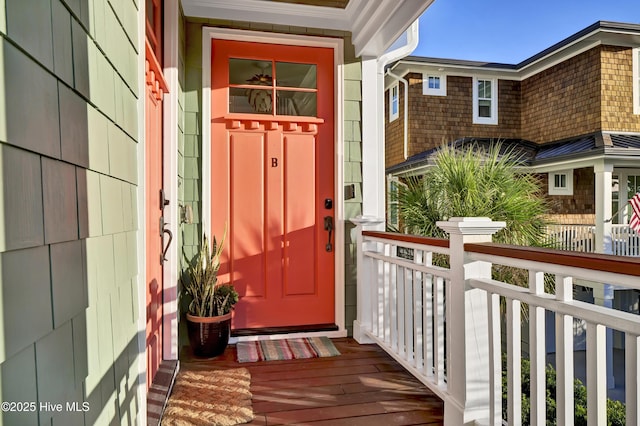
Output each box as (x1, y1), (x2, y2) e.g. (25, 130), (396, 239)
(354, 218), (640, 425)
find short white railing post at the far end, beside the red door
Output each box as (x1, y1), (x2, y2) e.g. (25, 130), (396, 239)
(351, 216), (384, 344)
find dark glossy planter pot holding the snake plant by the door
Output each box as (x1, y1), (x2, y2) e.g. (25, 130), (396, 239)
(187, 313), (231, 358)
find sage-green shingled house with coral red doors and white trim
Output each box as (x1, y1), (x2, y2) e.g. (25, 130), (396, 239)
(0, 0), (431, 425)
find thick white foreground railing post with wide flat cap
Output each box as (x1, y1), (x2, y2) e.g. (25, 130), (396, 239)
(437, 217), (506, 425)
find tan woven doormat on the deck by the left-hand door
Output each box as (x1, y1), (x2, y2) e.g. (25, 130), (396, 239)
(161, 368), (253, 426)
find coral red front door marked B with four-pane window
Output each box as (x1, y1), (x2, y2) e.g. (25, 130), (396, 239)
(211, 40), (335, 329)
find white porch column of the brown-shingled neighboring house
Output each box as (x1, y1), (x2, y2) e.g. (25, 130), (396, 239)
(593, 161), (615, 389)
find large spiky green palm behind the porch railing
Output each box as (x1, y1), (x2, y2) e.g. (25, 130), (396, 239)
(397, 142), (547, 246)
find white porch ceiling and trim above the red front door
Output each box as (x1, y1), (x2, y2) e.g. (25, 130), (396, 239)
(182, 0), (433, 57)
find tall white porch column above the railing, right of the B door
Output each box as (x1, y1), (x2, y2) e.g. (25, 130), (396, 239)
(362, 58), (386, 218)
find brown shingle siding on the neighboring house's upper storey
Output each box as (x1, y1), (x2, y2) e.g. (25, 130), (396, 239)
(386, 45), (640, 167)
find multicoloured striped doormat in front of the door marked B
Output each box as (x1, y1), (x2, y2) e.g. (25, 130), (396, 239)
(236, 336), (340, 362)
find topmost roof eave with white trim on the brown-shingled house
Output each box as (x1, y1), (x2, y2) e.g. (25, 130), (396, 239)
(393, 21), (640, 81)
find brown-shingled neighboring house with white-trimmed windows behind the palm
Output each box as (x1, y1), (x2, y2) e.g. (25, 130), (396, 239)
(385, 22), (640, 255)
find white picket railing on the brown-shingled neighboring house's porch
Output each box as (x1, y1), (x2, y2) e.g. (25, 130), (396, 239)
(545, 224), (640, 257)
